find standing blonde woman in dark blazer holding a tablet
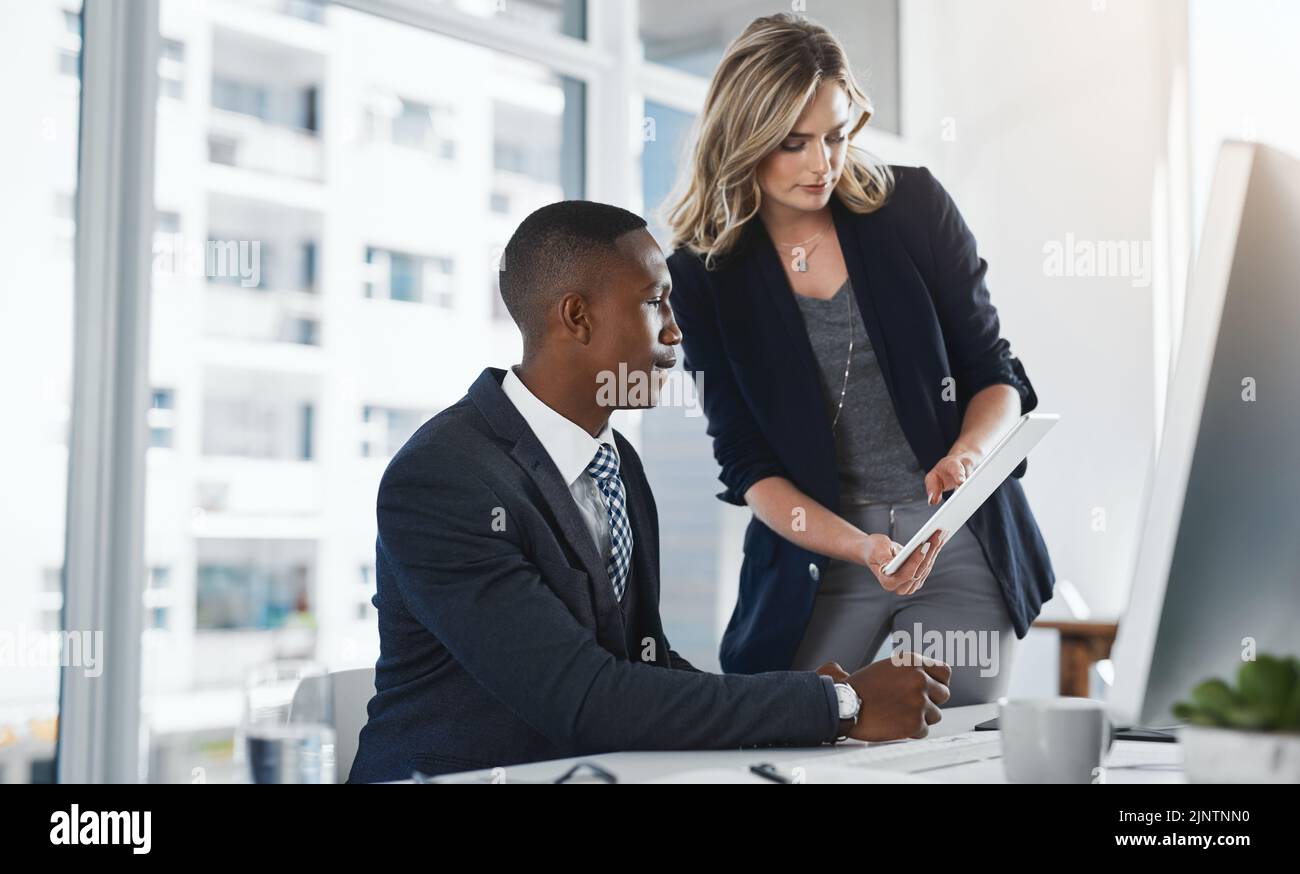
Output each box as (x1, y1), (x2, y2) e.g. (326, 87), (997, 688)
(668, 14), (1054, 705)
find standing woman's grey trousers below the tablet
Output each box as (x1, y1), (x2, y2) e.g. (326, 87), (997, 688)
(792, 501), (1017, 708)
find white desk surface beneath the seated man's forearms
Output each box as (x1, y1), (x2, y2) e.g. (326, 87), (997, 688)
(421, 704), (1186, 783)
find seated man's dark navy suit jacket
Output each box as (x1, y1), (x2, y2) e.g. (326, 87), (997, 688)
(348, 368), (839, 783)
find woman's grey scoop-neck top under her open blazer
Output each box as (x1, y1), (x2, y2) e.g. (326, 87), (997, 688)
(794, 273), (926, 505)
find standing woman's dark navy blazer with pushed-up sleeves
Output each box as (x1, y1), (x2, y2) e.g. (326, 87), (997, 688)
(668, 166), (1056, 672)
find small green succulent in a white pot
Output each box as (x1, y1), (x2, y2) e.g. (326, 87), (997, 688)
(1174, 647), (1300, 783)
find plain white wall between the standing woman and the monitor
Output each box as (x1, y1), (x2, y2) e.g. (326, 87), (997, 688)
(885, 0), (1186, 619)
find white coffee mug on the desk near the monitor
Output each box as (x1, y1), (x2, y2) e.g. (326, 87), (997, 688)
(997, 698), (1113, 783)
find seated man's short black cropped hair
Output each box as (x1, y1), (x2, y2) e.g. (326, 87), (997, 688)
(499, 200), (646, 343)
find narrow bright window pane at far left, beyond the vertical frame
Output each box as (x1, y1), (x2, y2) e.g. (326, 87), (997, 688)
(0, 0), (82, 783)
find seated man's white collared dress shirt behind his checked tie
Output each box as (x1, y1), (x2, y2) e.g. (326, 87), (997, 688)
(501, 368), (623, 562)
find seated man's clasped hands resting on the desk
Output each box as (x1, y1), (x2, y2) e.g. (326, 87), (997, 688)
(837, 653), (953, 740)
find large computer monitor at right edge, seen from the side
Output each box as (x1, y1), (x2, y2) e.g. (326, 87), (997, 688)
(1109, 142), (1300, 726)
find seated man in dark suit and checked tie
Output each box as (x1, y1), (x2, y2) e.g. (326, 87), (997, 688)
(350, 200), (950, 782)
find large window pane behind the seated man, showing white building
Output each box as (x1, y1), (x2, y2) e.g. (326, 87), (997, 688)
(137, 0), (590, 782)
